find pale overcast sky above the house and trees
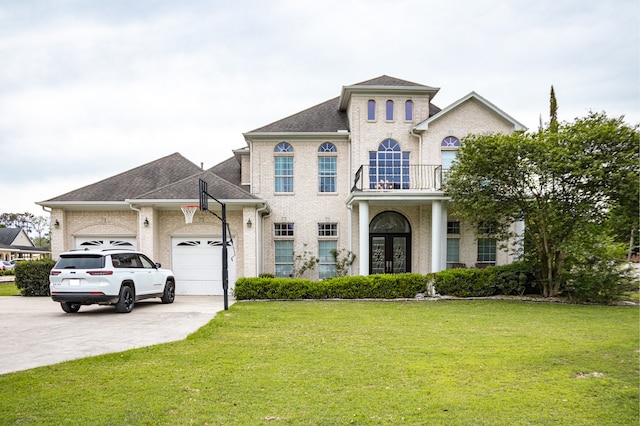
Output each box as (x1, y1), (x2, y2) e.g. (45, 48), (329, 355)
(0, 0), (640, 215)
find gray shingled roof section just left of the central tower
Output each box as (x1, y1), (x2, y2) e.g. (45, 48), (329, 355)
(249, 98), (349, 133)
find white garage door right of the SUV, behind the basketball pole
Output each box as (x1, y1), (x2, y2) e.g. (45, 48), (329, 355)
(171, 237), (236, 296)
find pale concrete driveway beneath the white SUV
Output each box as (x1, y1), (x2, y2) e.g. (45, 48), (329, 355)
(0, 296), (233, 374)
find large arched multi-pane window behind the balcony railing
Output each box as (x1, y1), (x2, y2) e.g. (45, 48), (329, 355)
(369, 139), (410, 189)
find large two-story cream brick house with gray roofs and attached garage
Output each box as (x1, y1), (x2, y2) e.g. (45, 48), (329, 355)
(38, 76), (525, 294)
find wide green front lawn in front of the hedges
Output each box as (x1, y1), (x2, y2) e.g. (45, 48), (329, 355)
(0, 300), (640, 425)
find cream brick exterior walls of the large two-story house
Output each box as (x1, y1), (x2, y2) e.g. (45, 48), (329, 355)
(41, 77), (521, 292)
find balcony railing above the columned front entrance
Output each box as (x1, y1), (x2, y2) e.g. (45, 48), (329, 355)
(351, 164), (443, 192)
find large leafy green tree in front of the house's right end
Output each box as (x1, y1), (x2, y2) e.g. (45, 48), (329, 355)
(444, 113), (639, 296)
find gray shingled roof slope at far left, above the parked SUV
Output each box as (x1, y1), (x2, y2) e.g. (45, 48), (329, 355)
(40, 152), (202, 205)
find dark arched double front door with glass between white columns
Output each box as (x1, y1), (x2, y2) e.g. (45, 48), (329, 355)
(369, 211), (411, 274)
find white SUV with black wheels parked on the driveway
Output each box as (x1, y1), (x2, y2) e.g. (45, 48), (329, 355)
(49, 249), (176, 313)
